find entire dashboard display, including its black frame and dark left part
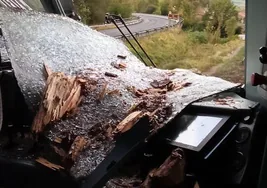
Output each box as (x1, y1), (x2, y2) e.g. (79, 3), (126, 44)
(163, 114), (230, 151)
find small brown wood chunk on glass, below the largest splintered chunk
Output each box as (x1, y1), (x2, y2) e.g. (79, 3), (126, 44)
(69, 136), (89, 161)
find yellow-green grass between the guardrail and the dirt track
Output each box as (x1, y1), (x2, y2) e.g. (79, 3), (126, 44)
(127, 29), (244, 72)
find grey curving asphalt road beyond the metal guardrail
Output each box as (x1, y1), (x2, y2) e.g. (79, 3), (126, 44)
(100, 13), (174, 37)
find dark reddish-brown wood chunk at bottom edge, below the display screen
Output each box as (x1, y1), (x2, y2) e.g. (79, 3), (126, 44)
(141, 149), (185, 188)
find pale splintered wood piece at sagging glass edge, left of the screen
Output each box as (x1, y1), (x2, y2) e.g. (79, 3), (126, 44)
(113, 111), (143, 134)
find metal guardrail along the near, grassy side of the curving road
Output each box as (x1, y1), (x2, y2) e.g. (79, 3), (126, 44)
(114, 19), (184, 40)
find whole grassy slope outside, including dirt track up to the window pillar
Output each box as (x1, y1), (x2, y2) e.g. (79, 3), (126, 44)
(126, 29), (245, 83)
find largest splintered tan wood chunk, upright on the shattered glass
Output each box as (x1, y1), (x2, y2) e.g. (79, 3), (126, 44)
(32, 67), (86, 133)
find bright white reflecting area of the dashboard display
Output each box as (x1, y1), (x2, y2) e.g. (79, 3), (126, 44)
(174, 116), (223, 147)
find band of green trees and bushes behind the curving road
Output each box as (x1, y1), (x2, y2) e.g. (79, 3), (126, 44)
(74, 0), (243, 42)
